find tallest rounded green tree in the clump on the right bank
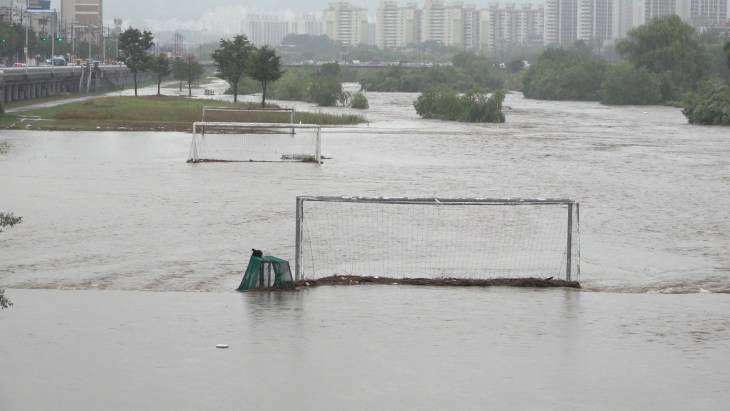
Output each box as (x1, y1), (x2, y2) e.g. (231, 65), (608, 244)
(616, 15), (708, 101)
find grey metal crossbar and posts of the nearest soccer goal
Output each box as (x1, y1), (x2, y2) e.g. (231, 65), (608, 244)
(295, 196), (580, 281)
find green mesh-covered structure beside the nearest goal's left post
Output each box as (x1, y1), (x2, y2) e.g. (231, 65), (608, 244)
(237, 250), (294, 291)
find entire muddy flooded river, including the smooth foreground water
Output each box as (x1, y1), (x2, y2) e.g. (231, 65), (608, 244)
(0, 85), (730, 410)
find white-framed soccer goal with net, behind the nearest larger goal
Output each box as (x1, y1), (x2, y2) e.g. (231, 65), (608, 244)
(188, 121), (322, 164)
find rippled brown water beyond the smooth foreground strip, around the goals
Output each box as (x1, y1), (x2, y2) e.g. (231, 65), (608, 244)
(0, 86), (730, 292)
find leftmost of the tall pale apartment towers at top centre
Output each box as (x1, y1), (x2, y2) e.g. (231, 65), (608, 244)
(322, 2), (370, 46)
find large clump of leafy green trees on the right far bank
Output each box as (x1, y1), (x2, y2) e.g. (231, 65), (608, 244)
(522, 16), (730, 111)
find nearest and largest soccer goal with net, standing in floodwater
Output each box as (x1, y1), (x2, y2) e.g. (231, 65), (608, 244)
(295, 197), (580, 281)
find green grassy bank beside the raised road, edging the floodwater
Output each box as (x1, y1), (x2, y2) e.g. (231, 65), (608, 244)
(0, 96), (365, 131)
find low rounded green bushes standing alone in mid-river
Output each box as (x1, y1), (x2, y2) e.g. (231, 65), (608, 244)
(414, 90), (505, 123)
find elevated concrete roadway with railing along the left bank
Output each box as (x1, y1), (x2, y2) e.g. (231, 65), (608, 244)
(0, 65), (145, 103)
